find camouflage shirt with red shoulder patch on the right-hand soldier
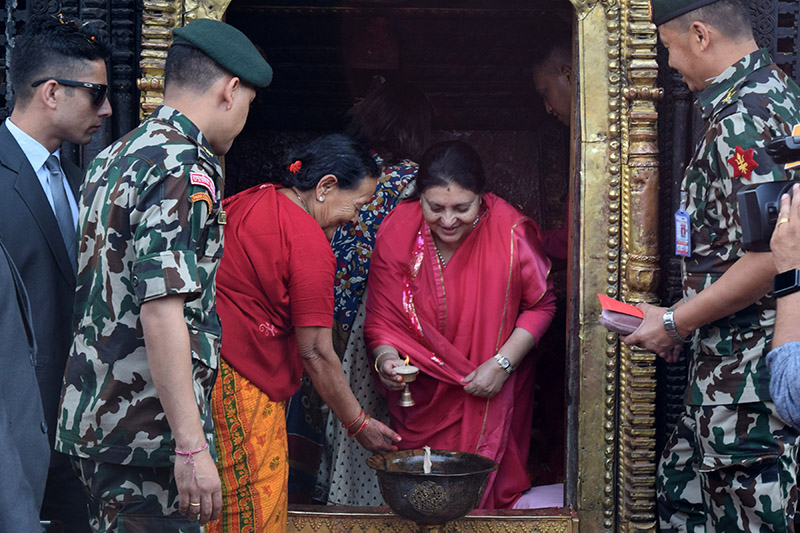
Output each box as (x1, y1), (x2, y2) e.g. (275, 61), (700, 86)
(682, 50), (800, 405)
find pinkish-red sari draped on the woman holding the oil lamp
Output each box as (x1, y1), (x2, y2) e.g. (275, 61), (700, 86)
(365, 194), (555, 509)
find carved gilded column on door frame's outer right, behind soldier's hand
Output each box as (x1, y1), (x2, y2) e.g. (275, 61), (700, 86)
(617, 0), (663, 531)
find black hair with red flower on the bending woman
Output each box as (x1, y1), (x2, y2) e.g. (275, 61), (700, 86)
(283, 133), (380, 191)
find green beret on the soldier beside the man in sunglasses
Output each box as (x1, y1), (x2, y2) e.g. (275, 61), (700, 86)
(172, 19), (272, 87)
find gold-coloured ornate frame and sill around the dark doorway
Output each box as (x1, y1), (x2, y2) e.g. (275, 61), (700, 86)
(137, 0), (661, 532)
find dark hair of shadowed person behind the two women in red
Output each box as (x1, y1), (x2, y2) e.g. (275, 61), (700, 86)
(347, 80), (435, 165)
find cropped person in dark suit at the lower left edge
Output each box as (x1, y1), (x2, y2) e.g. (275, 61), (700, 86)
(0, 237), (50, 531)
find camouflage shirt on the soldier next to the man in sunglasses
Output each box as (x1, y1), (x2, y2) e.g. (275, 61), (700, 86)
(56, 106), (222, 466)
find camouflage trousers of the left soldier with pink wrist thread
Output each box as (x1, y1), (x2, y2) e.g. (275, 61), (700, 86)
(72, 457), (203, 533)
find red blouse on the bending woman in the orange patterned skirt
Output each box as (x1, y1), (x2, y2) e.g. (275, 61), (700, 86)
(217, 184), (336, 401)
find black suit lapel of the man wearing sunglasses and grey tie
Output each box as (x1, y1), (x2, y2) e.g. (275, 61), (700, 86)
(0, 123), (75, 283)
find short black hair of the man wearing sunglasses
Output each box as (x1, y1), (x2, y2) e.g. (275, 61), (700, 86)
(9, 15), (109, 102)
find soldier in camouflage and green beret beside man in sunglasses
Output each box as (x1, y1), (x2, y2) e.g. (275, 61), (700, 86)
(56, 20), (272, 531)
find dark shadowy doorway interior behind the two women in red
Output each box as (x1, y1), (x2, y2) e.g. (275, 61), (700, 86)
(225, 0), (572, 502)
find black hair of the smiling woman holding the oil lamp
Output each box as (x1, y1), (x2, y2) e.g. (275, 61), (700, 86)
(416, 140), (486, 195)
